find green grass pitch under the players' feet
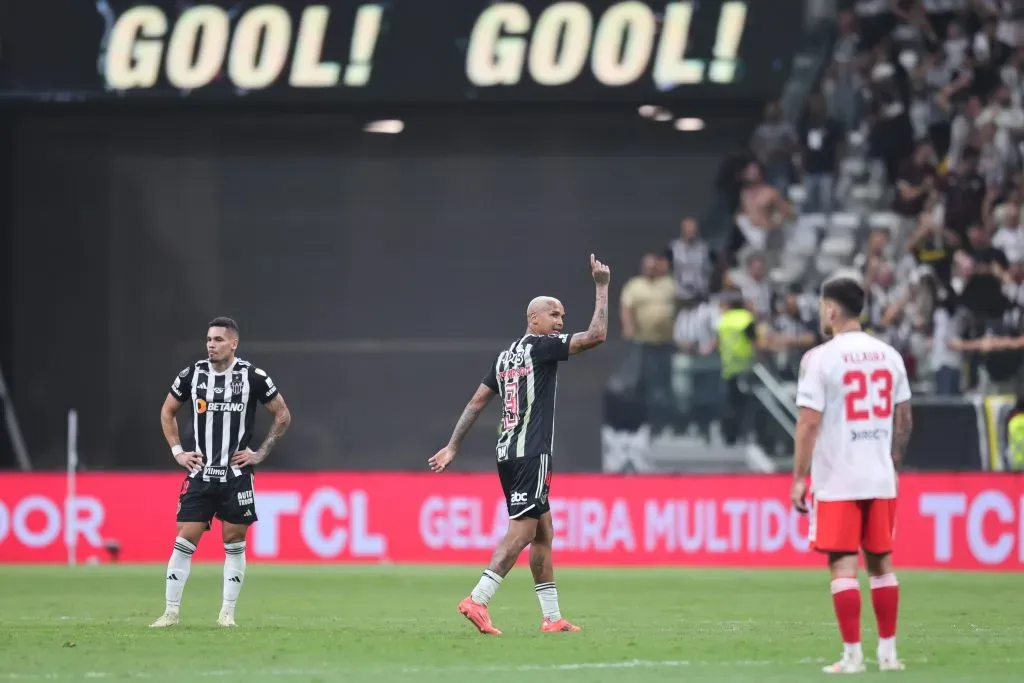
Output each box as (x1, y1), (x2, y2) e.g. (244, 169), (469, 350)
(0, 562), (1024, 683)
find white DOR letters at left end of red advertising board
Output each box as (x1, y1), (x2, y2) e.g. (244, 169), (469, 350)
(0, 496), (105, 548)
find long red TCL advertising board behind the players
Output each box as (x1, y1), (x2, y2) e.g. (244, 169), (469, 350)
(0, 472), (1024, 570)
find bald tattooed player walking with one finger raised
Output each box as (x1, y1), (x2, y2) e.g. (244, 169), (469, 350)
(429, 254), (611, 635)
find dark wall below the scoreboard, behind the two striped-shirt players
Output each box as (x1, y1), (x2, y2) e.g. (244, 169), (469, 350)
(6, 105), (758, 470)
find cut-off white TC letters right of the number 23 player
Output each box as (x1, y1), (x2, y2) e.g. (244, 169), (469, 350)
(921, 490), (1024, 564)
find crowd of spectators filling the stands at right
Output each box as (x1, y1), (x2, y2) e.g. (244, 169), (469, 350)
(621, 0), (1024, 446)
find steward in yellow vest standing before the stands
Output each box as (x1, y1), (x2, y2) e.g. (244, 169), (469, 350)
(718, 290), (758, 445)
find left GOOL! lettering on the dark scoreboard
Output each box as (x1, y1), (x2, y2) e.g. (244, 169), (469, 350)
(103, 4), (383, 90)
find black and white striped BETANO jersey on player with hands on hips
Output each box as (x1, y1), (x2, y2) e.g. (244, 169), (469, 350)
(171, 358), (278, 481)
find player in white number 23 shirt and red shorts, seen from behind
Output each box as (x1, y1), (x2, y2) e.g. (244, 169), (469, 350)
(792, 278), (911, 674)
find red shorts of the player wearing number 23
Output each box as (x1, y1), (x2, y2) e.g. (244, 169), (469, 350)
(808, 498), (896, 555)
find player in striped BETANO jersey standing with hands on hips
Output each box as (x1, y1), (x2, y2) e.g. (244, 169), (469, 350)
(150, 317), (292, 629)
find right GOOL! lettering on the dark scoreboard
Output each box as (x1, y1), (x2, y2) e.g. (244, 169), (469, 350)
(466, 0), (749, 88)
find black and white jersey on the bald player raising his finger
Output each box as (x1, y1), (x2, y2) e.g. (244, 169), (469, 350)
(483, 335), (570, 462)
